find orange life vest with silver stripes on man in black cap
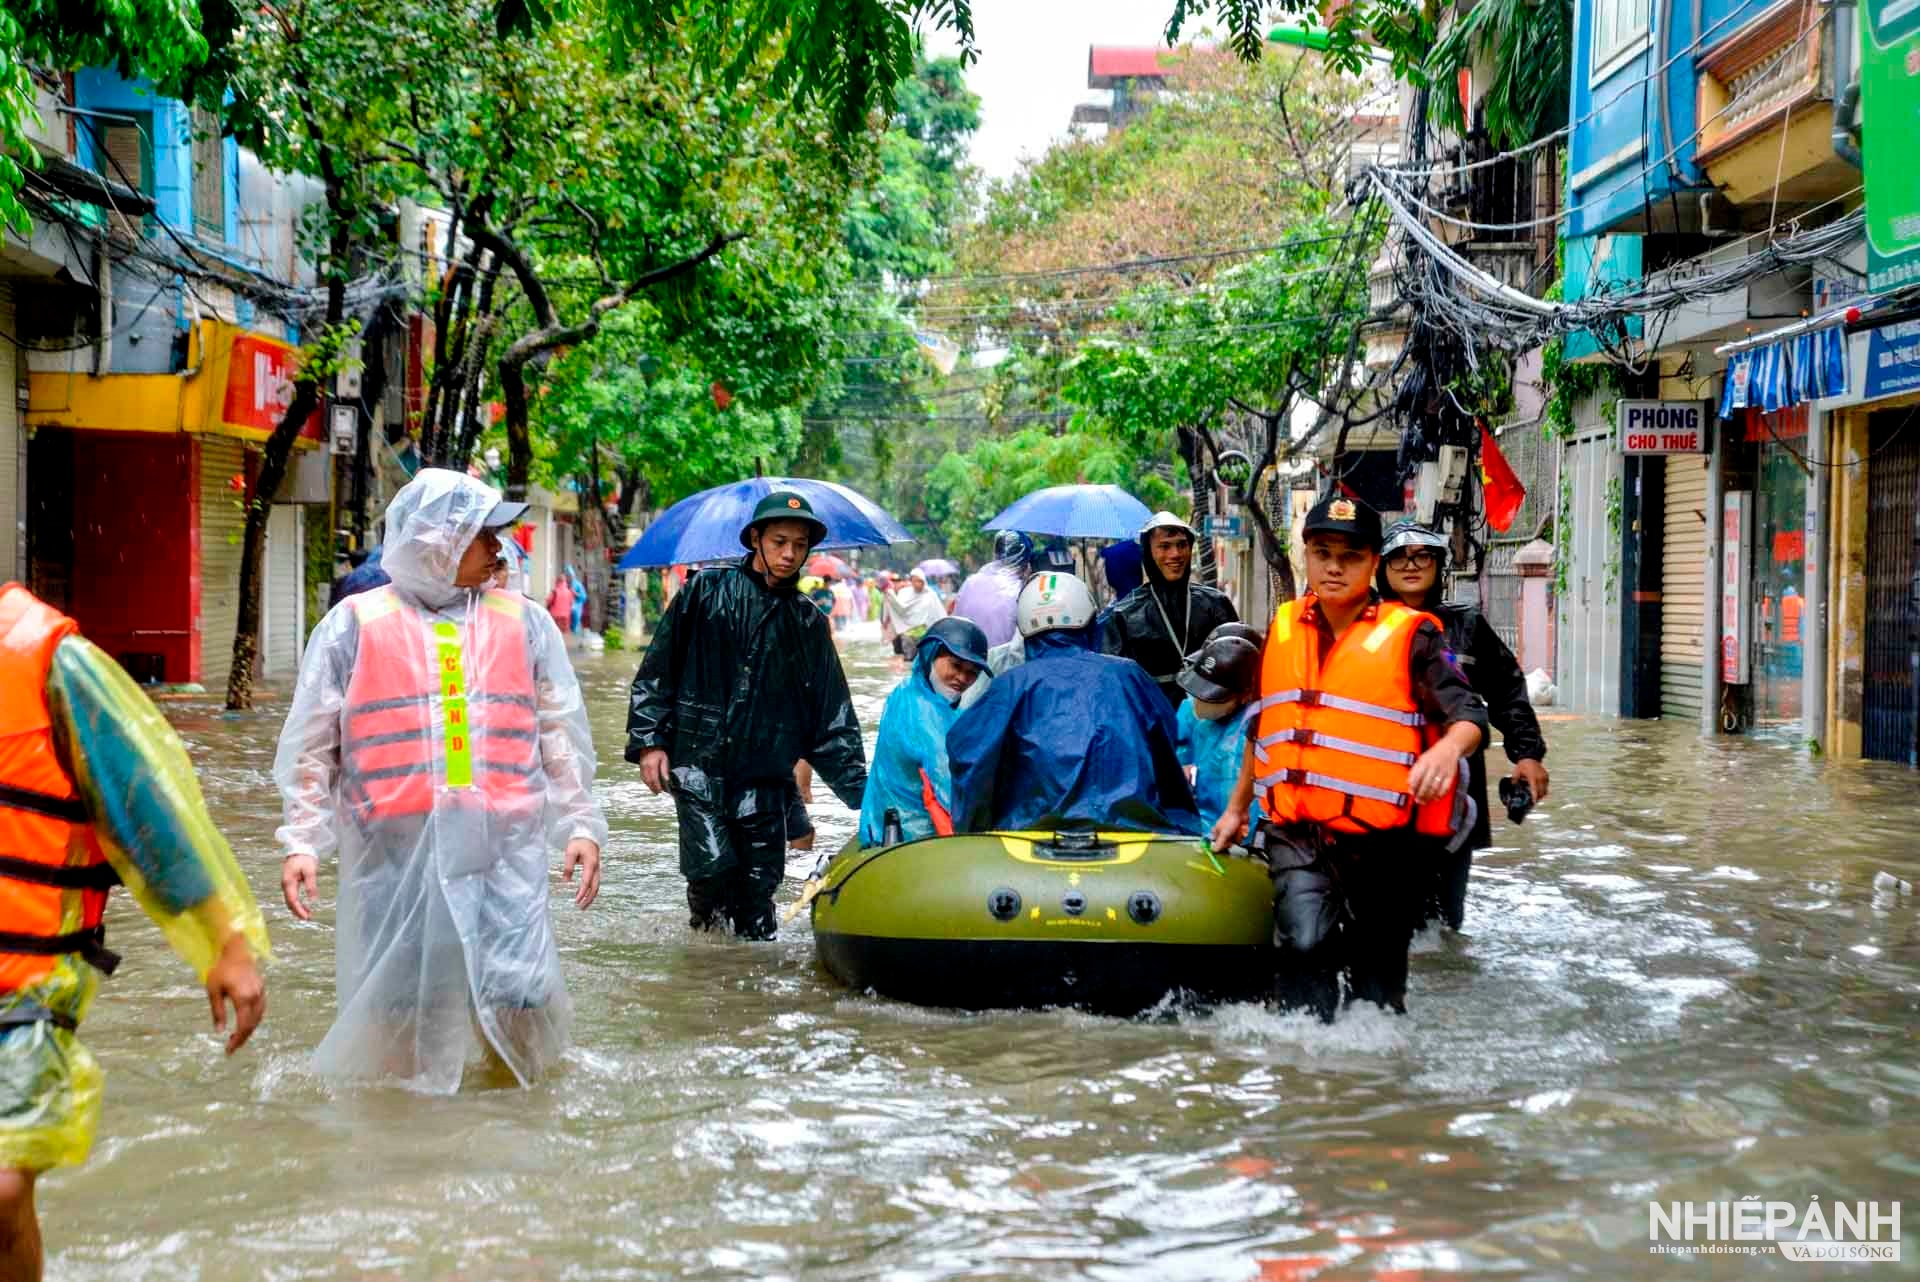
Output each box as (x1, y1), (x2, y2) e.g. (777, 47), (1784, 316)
(1254, 595), (1473, 837)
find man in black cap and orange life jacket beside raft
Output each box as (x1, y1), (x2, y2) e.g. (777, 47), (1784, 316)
(1213, 493), (1486, 1023)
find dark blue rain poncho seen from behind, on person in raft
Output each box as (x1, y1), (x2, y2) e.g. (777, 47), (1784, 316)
(947, 628), (1200, 833)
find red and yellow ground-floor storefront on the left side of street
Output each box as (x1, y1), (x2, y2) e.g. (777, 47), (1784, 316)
(25, 322), (321, 687)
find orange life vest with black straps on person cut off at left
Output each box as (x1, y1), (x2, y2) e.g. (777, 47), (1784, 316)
(0, 583), (119, 997)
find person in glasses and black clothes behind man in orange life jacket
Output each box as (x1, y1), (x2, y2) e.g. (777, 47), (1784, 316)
(1379, 520), (1548, 931)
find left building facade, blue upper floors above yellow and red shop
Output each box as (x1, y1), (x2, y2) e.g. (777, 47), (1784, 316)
(0, 69), (334, 685)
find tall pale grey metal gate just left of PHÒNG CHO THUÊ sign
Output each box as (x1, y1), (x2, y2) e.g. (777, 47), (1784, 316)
(1553, 420), (1624, 716)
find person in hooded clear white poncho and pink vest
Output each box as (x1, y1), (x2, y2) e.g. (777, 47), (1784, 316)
(273, 468), (607, 1092)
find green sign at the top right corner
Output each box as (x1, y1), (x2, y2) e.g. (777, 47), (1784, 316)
(1860, 0), (1920, 294)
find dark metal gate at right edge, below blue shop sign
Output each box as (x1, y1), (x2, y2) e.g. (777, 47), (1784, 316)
(1860, 411), (1920, 766)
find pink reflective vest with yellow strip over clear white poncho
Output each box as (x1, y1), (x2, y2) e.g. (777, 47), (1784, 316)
(342, 587), (545, 823)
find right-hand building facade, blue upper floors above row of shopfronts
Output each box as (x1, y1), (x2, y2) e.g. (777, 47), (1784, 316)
(1559, 0), (1920, 764)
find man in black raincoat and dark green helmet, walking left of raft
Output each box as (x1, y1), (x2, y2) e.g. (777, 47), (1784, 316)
(626, 491), (866, 938)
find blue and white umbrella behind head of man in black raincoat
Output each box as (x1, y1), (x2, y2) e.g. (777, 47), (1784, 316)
(618, 476), (914, 570)
